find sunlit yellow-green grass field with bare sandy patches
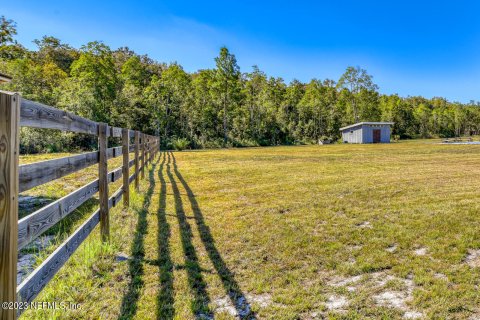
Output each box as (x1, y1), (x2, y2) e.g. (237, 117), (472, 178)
(23, 140), (480, 319)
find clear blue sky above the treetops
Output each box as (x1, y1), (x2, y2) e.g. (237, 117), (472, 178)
(0, 0), (480, 102)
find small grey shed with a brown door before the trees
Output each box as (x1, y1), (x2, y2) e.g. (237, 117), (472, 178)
(340, 122), (393, 143)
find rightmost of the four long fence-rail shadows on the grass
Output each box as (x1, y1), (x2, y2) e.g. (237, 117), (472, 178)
(171, 153), (256, 319)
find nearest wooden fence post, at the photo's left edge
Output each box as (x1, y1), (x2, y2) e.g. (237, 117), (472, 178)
(0, 92), (20, 320)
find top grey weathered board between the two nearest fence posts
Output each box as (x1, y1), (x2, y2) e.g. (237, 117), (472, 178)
(20, 99), (98, 135)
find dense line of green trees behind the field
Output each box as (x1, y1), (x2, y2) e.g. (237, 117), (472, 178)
(0, 17), (480, 153)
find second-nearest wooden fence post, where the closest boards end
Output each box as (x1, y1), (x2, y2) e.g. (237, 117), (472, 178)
(98, 123), (110, 242)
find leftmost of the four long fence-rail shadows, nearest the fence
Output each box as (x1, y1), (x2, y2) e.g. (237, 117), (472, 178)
(119, 160), (158, 319)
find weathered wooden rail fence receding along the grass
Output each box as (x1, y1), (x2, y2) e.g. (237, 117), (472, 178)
(0, 92), (160, 319)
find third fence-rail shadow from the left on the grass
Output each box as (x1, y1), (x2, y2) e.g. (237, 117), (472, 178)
(167, 153), (213, 319)
